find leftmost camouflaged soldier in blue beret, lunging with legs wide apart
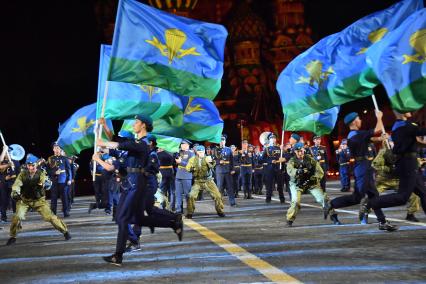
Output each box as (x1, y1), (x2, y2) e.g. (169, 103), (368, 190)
(6, 154), (71, 245)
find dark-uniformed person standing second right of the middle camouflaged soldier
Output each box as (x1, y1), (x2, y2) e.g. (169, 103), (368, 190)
(240, 140), (254, 199)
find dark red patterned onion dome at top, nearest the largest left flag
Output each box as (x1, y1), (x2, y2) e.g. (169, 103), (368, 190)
(227, 1), (266, 42)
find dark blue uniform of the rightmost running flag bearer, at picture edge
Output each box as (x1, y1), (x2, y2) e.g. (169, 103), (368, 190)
(367, 120), (426, 213)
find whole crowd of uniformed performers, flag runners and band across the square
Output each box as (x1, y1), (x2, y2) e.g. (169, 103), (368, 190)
(0, 111), (426, 265)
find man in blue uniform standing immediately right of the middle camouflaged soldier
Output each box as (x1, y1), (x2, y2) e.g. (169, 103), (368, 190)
(213, 134), (236, 207)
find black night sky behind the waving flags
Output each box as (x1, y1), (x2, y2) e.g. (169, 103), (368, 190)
(0, 0), (412, 178)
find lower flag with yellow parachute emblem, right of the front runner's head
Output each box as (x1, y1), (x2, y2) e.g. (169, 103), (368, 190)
(120, 95), (223, 143)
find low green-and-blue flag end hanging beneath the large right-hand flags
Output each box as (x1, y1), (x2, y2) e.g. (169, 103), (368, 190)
(284, 106), (340, 136)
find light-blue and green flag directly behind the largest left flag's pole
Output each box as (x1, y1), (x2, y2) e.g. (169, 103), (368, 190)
(97, 45), (178, 119)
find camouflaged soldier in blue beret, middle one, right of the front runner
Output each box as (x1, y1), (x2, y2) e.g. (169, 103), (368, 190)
(186, 145), (225, 219)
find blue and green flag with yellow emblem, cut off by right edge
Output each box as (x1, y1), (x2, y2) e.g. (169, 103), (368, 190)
(367, 9), (426, 112)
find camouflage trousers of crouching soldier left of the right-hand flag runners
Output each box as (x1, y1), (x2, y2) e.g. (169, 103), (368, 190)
(287, 181), (336, 221)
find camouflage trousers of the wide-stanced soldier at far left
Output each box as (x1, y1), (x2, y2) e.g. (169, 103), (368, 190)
(10, 197), (67, 238)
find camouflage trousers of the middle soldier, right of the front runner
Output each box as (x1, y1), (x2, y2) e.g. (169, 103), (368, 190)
(187, 180), (224, 214)
